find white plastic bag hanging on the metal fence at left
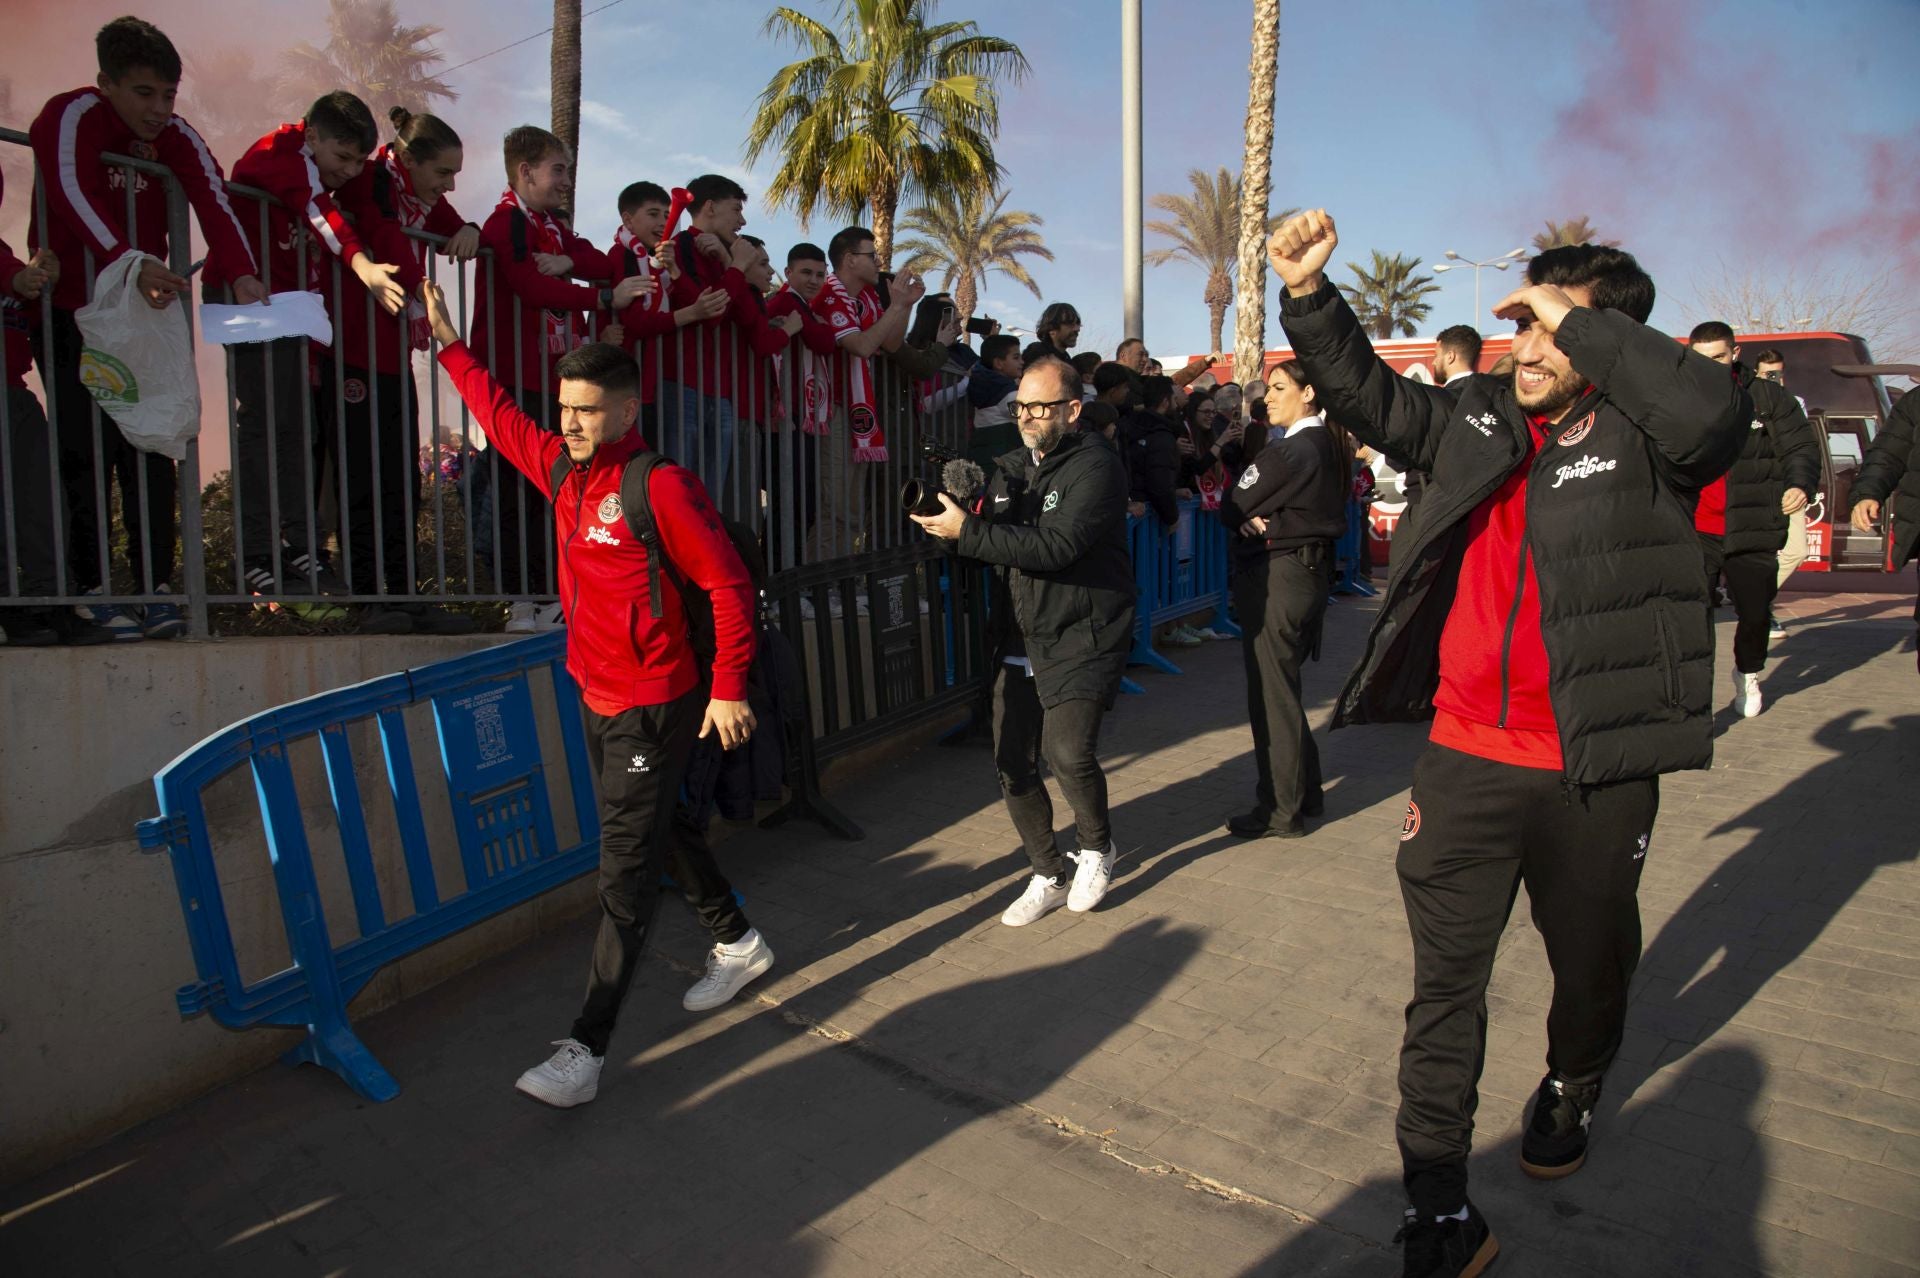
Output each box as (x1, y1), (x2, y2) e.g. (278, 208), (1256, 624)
(73, 253), (200, 461)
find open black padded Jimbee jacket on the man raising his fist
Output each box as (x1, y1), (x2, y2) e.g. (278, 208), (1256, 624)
(1281, 284), (1753, 785)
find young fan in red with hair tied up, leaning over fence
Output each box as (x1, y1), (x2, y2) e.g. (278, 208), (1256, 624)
(319, 107), (480, 635)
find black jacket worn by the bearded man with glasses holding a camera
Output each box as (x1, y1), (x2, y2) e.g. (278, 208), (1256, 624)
(958, 432), (1135, 706)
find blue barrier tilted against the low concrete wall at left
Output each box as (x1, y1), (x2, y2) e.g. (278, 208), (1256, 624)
(138, 631), (599, 1101)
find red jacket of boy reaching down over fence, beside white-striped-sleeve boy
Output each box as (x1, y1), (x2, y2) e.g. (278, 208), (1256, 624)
(224, 123), (372, 294)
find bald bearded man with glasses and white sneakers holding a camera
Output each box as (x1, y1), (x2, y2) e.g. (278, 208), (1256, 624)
(914, 359), (1135, 927)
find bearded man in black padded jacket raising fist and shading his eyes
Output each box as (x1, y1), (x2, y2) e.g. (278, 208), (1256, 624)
(1267, 209), (1753, 1278)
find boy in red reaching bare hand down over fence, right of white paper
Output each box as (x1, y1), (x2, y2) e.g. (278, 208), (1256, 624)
(218, 90), (405, 595)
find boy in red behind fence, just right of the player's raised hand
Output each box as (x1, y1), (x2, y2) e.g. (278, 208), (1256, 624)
(472, 125), (645, 633)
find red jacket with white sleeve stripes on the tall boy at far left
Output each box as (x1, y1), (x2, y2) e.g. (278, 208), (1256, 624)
(27, 88), (259, 311)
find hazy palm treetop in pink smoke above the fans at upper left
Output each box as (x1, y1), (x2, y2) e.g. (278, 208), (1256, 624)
(280, 0), (459, 121)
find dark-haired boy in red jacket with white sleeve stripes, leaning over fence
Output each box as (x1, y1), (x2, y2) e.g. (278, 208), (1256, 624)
(27, 17), (267, 639)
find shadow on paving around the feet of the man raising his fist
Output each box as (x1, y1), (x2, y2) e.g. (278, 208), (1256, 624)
(1240, 1048), (1766, 1278)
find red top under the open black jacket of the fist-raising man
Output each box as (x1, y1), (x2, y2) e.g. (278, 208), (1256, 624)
(1430, 408), (1563, 771)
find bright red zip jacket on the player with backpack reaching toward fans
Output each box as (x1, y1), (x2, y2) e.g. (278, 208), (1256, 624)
(440, 342), (755, 714)
